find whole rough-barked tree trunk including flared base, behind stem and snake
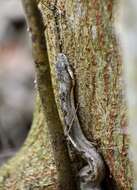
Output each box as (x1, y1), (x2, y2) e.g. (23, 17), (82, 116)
(0, 0), (132, 190)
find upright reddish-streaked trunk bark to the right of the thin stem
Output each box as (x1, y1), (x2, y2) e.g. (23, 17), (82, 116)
(41, 0), (132, 189)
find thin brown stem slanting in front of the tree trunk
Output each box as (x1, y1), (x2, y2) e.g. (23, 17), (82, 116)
(22, 0), (76, 190)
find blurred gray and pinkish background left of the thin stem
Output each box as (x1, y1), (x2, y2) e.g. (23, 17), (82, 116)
(0, 0), (35, 165)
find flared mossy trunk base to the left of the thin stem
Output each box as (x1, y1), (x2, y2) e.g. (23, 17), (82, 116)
(0, 96), (57, 190)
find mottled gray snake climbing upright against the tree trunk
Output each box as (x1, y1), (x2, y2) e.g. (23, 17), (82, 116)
(56, 53), (105, 190)
